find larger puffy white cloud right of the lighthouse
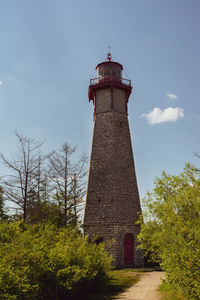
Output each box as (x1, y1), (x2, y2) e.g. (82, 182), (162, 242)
(141, 107), (184, 125)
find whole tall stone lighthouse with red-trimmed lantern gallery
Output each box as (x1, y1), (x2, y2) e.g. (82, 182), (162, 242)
(84, 52), (143, 267)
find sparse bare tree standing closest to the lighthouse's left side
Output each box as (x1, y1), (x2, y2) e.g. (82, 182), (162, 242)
(49, 143), (87, 226)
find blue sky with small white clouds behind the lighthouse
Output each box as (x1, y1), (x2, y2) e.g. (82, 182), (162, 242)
(0, 0), (200, 202)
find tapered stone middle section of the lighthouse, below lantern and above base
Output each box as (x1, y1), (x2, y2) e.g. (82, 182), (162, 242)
(85, 111), (141, 224)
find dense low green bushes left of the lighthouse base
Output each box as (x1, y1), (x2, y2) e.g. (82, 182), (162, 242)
(0, 222), (111, 300)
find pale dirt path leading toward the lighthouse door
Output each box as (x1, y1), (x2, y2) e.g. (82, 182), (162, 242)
(115, 271), (164, 300)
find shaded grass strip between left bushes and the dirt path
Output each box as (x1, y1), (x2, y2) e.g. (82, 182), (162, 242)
(81, 269), (143, 300)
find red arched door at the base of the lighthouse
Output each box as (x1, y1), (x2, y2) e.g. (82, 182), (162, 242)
(124, 233), (134, 265)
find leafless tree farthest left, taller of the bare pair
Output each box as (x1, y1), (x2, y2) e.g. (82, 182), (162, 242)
(0, 132), (51, 221)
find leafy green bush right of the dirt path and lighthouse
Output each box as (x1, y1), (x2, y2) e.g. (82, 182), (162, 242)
(139, 165), (200, 299)
